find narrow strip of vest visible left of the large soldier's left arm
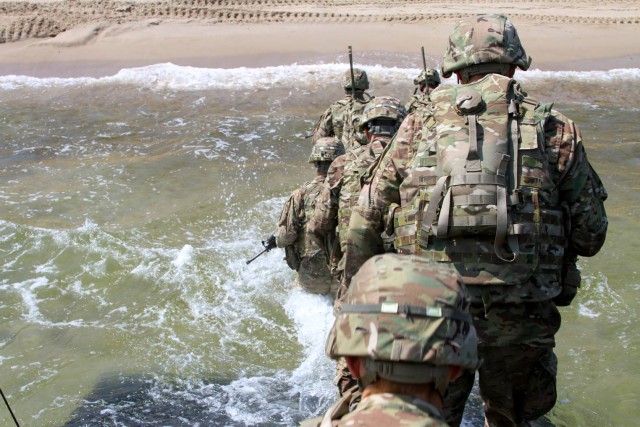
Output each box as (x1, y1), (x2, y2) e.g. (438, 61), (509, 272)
(338, 137), (390, 253)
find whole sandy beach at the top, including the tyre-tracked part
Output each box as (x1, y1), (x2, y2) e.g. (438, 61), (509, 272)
(0, 0), (640, 77)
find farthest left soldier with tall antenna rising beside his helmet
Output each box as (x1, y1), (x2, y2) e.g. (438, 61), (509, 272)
(312, 68), (372, 149)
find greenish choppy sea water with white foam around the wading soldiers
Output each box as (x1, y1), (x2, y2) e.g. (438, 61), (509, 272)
(0, 52), (640, 426)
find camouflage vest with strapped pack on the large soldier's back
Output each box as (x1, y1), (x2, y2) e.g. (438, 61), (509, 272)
(392, 74), (565, 285)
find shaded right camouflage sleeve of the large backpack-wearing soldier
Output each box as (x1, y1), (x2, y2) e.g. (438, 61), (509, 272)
(545, 111), (608, 256)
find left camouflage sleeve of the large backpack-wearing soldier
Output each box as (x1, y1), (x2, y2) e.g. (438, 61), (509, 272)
(343, 115), (417, 288)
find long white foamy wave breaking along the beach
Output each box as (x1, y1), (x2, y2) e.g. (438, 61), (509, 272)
(0, 63), (640, 91)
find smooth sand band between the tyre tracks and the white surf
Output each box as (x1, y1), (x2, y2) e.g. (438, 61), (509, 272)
(0, 8), (640, 77)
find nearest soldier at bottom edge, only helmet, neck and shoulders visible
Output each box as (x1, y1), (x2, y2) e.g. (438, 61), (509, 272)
(303, 254), (478, 427)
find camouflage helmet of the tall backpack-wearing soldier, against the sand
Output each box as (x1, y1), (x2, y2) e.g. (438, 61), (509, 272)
(442, 14), (531, 77)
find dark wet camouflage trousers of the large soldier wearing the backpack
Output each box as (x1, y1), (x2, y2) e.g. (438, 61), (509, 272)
(444, 301), (560, 427)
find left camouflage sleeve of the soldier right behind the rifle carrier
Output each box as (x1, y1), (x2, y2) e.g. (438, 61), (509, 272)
(307, 154), (345, 247)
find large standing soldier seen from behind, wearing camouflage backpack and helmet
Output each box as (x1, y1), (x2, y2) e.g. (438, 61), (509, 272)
(344, 14), (607, 426)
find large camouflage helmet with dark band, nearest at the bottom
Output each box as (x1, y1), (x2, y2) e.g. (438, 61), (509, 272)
(325, 253), (478, 391)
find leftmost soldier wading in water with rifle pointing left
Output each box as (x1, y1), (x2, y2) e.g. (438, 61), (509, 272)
(274, 137), (344, 296)
